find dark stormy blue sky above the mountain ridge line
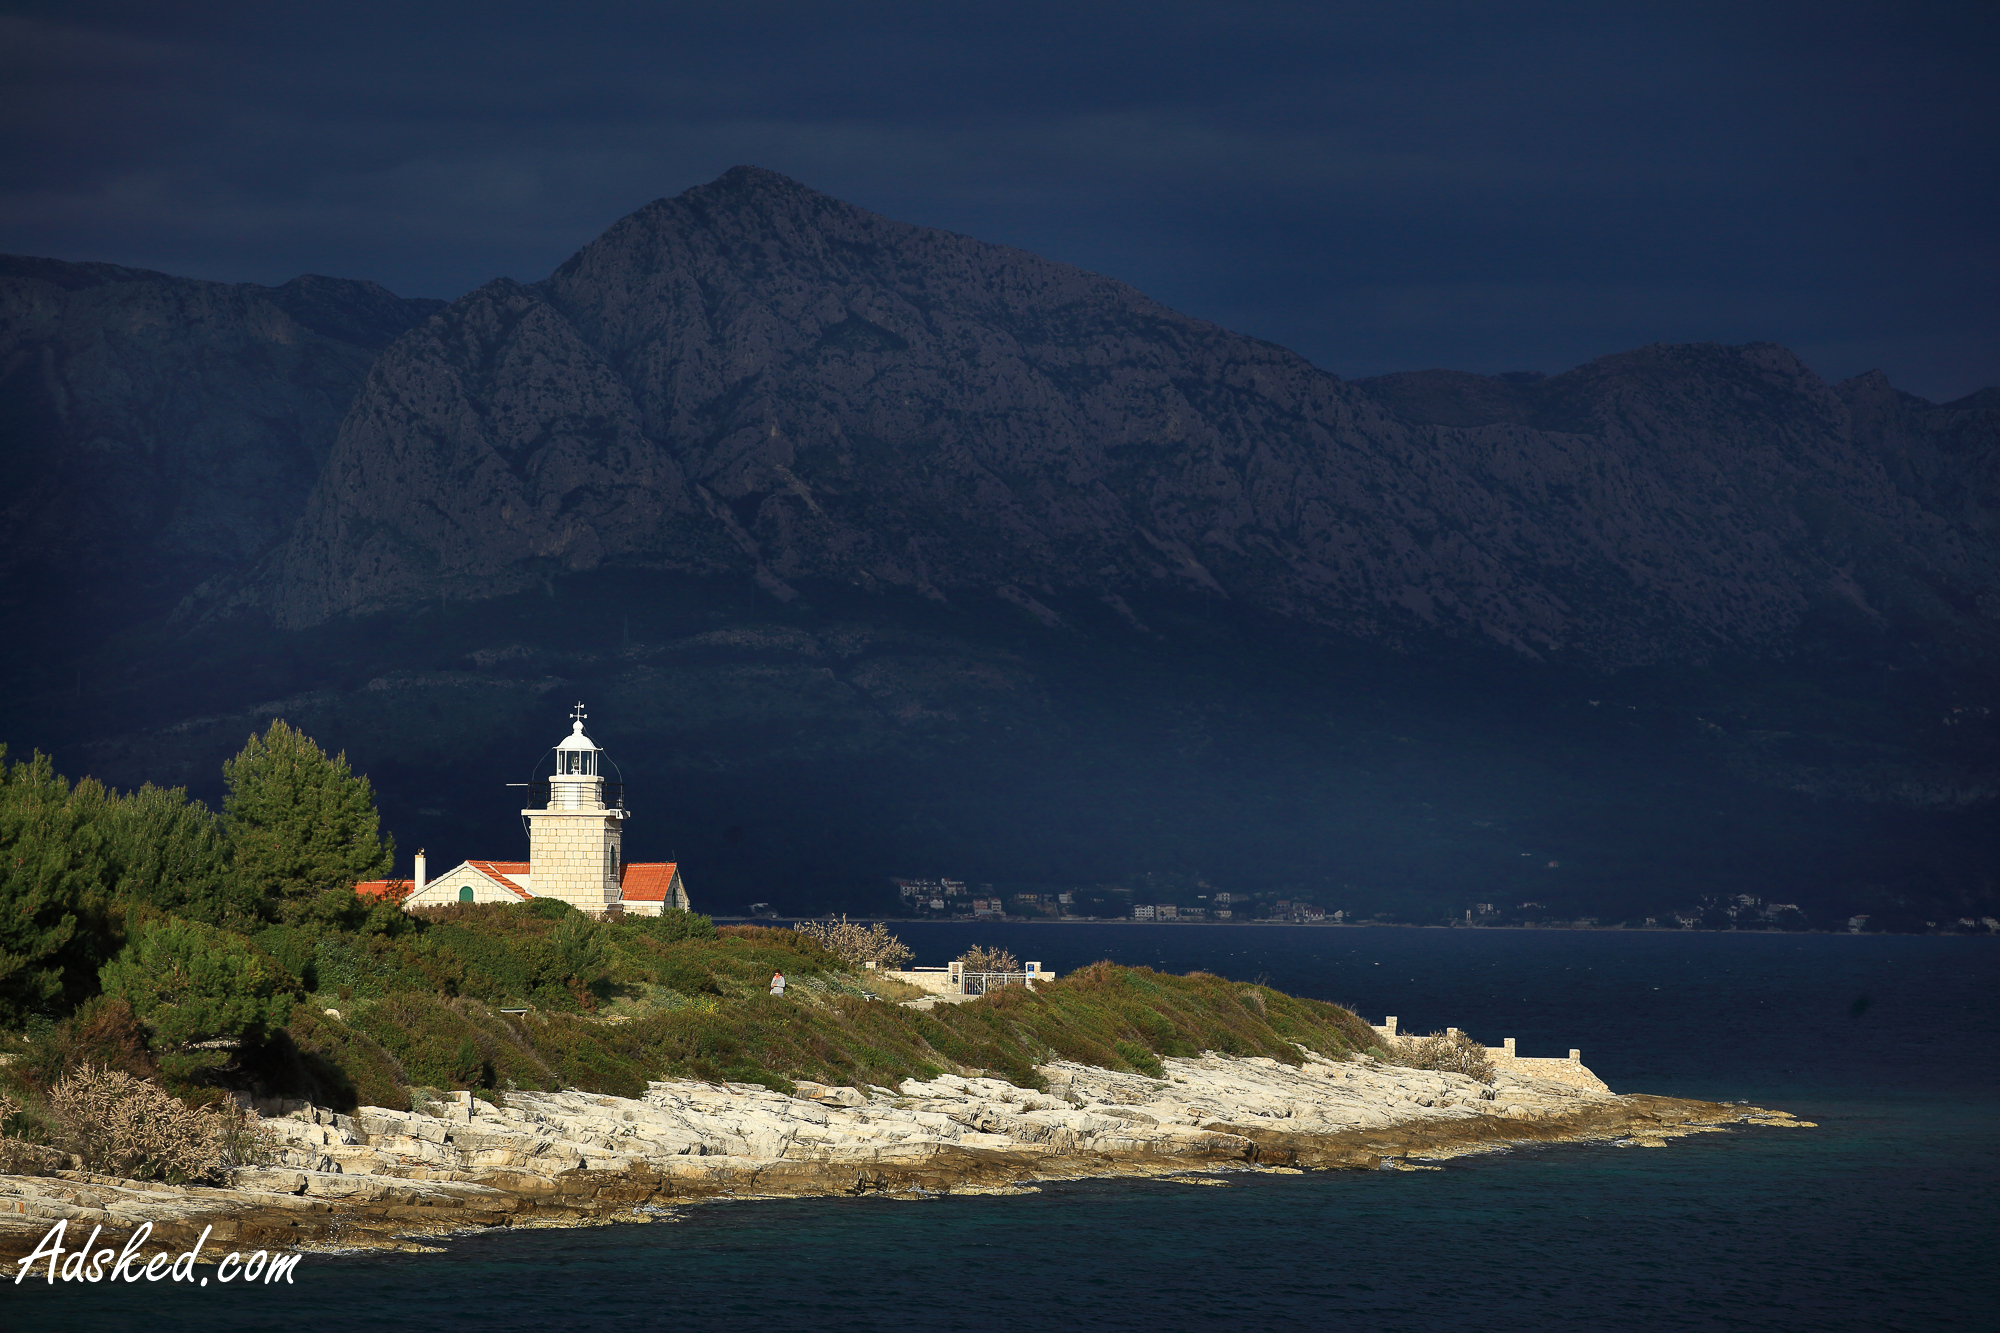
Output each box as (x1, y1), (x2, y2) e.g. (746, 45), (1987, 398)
(11, 0), (2000, 400)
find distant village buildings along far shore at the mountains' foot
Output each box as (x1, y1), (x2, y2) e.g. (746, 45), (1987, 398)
(888, 877), (2000, 935)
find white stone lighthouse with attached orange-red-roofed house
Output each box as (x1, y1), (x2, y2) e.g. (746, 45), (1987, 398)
(354, 705), (692, 917)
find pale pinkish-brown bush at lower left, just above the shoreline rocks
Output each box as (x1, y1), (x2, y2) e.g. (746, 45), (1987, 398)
(48, 1065), (270, 1185)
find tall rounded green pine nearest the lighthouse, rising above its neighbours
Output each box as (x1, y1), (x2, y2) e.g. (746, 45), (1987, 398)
(222, 719), (396, 921)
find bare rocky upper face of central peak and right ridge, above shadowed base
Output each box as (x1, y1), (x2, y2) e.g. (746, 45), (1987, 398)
(254, 168), (2000, 667)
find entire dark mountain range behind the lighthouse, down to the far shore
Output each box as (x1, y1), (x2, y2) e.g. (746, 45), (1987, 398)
(0, 168), (2000, 929)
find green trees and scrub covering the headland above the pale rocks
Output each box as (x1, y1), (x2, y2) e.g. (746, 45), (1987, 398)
(0, 723), (1376, 1179)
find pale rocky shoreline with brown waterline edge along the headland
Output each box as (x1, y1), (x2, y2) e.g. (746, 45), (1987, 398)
(0, 1055), (1810, 1261)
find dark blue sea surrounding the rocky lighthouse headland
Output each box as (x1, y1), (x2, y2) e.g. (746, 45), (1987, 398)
(0, 925), (2000, 1333)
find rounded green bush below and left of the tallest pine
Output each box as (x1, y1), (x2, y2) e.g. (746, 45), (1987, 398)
(98, 917), (296, 1047)
